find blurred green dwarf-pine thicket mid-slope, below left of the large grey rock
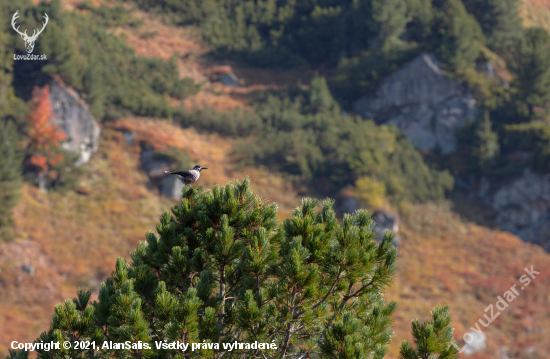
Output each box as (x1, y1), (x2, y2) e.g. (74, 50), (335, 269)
(237, 78), (453, 202)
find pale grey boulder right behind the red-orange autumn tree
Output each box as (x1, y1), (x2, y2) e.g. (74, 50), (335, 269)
(49, 75), (100, 166)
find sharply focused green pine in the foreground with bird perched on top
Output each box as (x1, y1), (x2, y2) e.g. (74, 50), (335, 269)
(5, 179), (462, 358)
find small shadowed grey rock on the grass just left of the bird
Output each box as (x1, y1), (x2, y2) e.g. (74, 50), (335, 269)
(140, 146), (183, 199)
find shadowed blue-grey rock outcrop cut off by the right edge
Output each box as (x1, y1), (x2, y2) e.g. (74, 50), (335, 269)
(478, 168), (550, 251)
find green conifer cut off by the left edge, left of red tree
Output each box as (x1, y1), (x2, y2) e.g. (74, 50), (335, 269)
(0, 120), (23, 239)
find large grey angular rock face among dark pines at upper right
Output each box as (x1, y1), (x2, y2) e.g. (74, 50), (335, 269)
(352, 53), (477, 154)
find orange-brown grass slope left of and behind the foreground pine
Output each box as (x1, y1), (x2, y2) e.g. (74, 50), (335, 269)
(0, 119), (299, 357)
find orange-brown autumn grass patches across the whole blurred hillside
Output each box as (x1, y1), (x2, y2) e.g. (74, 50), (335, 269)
(0, 0), (550, 359)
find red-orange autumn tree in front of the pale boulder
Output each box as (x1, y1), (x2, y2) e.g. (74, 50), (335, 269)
(28, 85), (67, 172)
